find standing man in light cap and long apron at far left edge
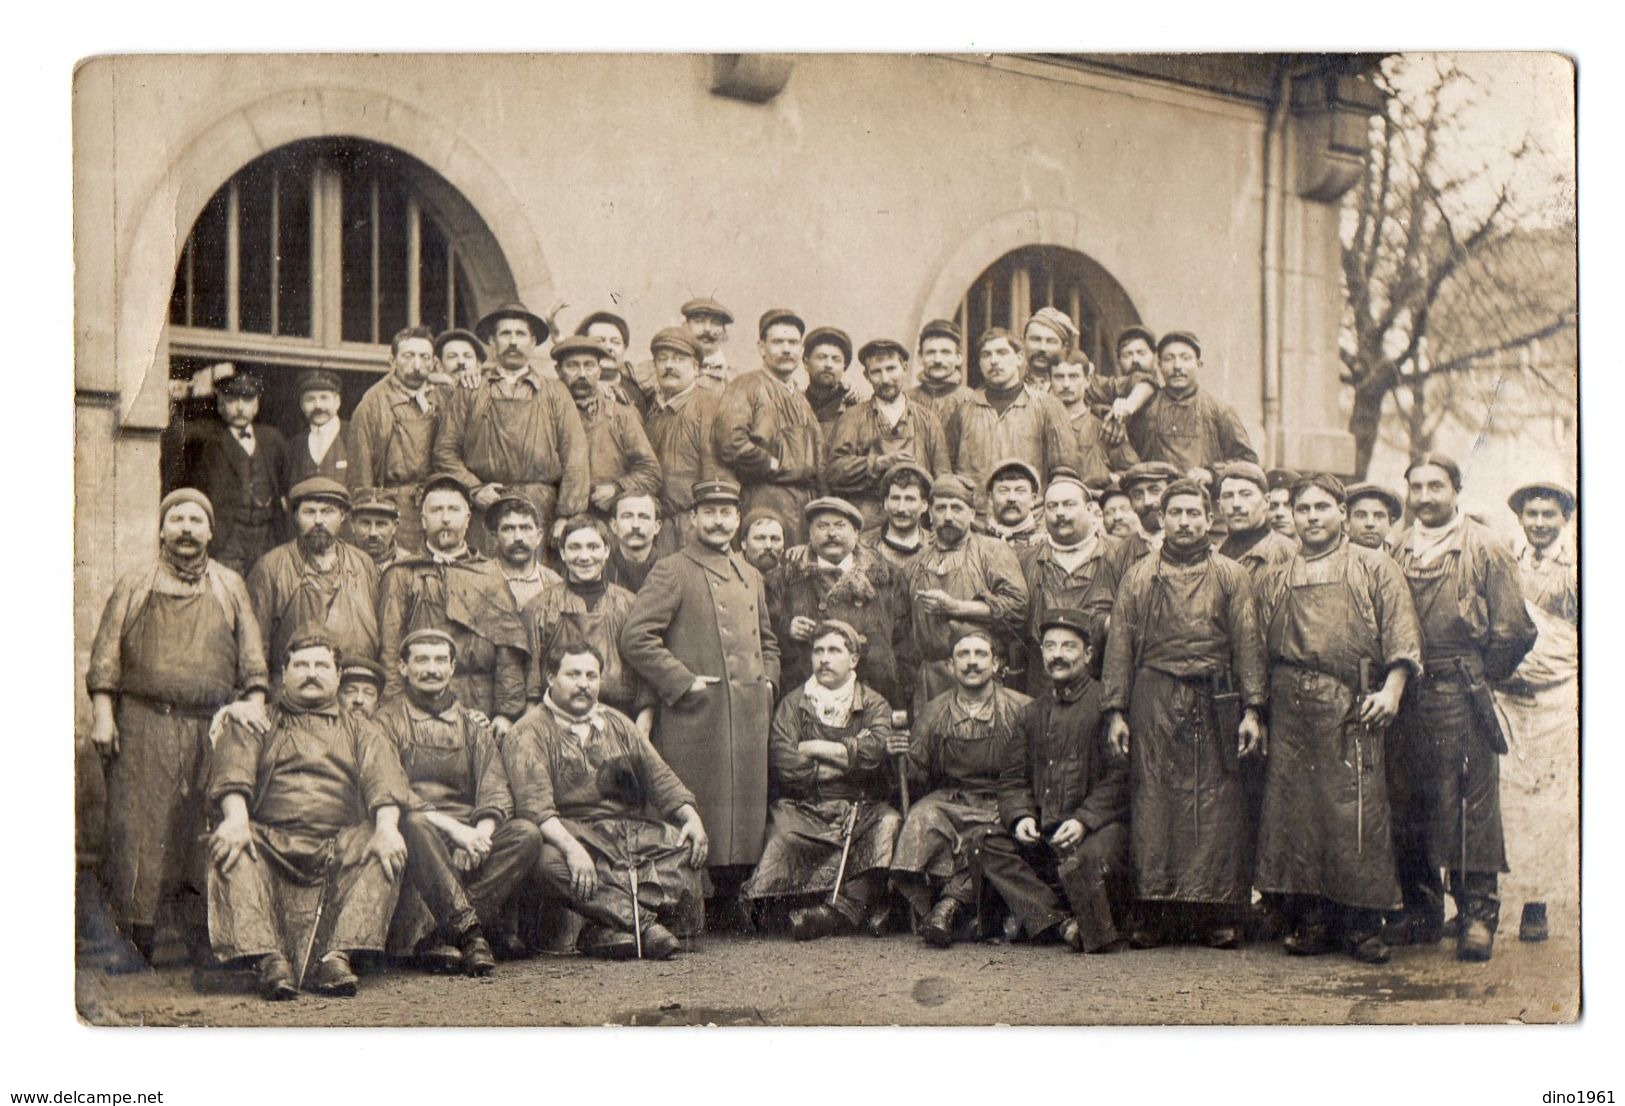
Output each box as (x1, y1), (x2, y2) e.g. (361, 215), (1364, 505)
(85, 487), (270, 970)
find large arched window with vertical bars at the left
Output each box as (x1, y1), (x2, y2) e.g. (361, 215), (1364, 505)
(169, 138), (514, 432)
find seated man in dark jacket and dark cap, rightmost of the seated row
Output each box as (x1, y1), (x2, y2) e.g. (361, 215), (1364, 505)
(999, 607), (1134, 952)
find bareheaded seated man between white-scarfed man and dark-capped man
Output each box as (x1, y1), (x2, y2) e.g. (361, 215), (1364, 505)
(887, 629), (1079, 948)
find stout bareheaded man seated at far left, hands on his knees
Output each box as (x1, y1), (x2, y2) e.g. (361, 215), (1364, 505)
(208, 635), (411, 1000)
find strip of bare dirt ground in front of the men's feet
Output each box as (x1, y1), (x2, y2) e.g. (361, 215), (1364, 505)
(76, 918), (1580, 1026)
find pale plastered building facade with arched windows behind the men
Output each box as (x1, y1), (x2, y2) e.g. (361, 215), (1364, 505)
(73, 55), (1376, 721)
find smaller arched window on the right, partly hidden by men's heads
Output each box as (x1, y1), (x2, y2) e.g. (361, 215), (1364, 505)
(954, 245), (1139, 387)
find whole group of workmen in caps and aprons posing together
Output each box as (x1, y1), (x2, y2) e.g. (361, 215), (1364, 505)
(88, 300), (1578, 999)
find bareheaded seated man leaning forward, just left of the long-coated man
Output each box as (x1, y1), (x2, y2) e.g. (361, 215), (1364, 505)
(502, 642), (710, 960)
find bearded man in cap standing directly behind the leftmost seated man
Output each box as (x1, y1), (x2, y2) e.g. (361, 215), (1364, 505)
(249, 476), (379, 672)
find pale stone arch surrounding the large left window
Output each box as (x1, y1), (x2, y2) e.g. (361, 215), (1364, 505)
(114, 88), (553, 432)
